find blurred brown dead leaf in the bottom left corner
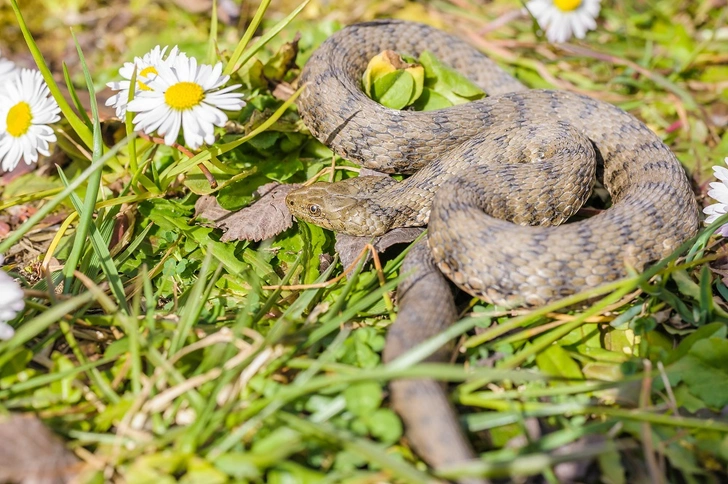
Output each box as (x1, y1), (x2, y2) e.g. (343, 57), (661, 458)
(0, 415), (81, 484)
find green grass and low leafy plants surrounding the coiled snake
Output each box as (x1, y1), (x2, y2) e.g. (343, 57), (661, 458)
(0, 0), (728, 483)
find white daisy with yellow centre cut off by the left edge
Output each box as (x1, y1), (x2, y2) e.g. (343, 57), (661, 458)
(0, 69), (61, 171)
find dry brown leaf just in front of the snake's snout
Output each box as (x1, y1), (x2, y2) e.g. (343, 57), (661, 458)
(195, 182), (301, 242)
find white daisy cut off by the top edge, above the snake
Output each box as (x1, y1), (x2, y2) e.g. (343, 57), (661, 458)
(526, 0), (601, 43)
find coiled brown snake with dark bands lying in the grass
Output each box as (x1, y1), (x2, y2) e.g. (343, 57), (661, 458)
(286, 20), (699, 483)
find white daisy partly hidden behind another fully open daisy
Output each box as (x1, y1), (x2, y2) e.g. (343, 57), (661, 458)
(106, 45), (187, 118)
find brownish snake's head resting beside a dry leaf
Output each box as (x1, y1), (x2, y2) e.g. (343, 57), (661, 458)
(286, 176), (391, 237)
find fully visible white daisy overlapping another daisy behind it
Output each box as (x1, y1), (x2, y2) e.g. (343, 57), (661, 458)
(128, 57), (245, 150)
